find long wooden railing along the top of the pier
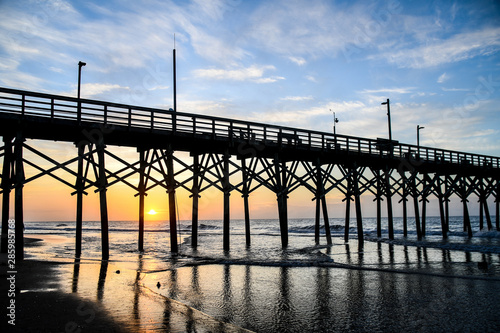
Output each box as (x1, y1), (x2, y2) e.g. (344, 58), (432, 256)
(0, 87), (500, 168)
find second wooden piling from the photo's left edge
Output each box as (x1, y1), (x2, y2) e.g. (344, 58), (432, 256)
(14, 132), (25, 260)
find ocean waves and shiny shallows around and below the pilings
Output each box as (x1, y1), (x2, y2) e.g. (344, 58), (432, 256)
(22, 217), (500, 332)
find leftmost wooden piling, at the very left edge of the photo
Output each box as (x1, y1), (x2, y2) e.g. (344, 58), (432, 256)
(0, 136), (12, 253)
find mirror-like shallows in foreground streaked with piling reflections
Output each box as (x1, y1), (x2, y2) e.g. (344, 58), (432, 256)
(62, 243), (500, 332)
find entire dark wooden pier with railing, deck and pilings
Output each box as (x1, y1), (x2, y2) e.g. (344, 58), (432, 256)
(0, 88), (500, 260)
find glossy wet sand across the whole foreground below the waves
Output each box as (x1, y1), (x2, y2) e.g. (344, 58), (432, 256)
(0, 237), (500, 332)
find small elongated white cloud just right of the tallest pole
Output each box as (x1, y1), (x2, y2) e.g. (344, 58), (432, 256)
(193, 65), (284, 83)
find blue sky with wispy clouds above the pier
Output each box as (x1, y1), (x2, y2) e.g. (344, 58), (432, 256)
(0, 0), (500, 223)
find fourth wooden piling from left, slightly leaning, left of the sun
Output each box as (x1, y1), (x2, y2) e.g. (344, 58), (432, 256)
(97, 143), (109, 260)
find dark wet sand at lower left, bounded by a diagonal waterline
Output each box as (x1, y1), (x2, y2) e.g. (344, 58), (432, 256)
(0, 236), (248, 332)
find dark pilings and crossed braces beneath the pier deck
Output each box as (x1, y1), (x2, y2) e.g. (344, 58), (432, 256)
(1, 133), (500, 260)
